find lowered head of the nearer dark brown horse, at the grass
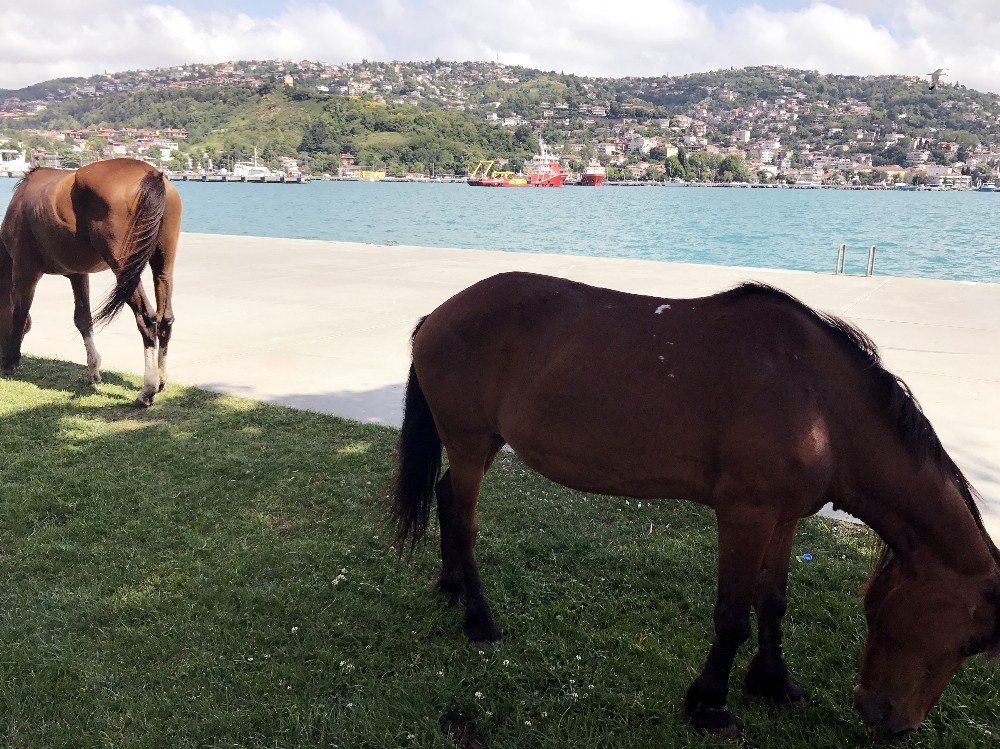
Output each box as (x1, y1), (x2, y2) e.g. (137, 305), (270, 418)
(854, 562), (1000, 738)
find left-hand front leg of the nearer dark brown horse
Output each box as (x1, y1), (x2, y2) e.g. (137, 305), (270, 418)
(684, 507), (775, 737)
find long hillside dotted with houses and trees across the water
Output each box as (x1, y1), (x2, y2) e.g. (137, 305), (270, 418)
(0, 60), (1000, 178)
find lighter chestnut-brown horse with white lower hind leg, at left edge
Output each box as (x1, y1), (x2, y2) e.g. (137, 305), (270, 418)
(0, 159), (181, 406)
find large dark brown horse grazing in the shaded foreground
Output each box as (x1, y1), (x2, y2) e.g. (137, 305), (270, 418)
(392, 273), (1000, 737)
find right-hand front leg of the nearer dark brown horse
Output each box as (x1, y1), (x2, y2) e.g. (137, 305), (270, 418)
(746, 520), (804, 705)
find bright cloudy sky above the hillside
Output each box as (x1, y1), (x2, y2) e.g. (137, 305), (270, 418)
(0, 0), (1000, 93)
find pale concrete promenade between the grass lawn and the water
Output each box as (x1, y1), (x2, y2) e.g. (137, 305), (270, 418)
(17, 234), (1000, 538)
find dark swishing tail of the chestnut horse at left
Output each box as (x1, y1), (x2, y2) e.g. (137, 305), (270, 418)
(94, 169), (167, 323)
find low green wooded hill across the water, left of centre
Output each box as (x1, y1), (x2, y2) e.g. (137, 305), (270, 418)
(17, 86), (537, 174)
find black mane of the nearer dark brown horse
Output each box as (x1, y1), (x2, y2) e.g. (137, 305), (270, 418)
(728, 283), (1000, 578)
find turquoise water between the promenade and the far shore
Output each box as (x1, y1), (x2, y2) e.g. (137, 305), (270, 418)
(0, 179), (1000, 282)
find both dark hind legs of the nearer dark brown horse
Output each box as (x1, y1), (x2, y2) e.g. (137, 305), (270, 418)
(438, 435), (503, 642)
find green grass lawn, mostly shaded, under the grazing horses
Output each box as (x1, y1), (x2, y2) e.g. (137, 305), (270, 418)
(0, 359), (1000, 749)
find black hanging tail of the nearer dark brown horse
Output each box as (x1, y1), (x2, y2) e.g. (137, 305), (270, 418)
(389, 320), (441, 551)
